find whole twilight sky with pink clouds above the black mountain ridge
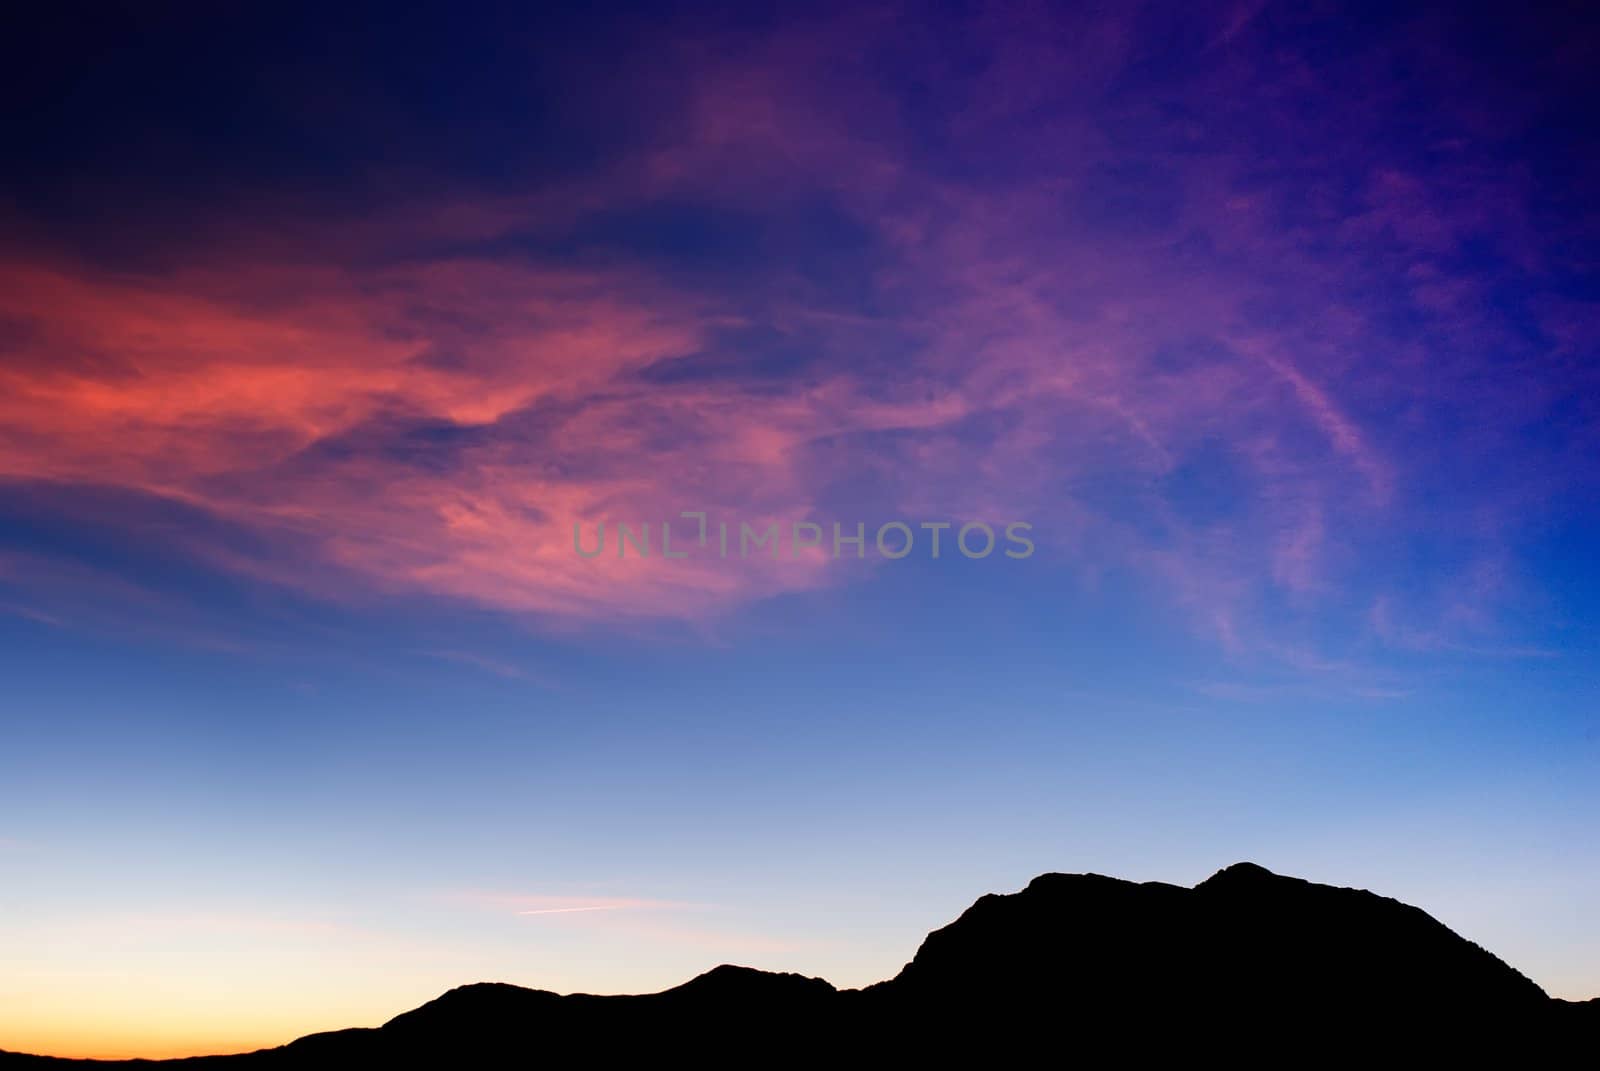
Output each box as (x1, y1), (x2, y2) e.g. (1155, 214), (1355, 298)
(0, 2), (1600, 1057)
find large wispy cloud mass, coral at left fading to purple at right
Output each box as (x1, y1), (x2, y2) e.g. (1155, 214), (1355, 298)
(0, 3), (1595, 662)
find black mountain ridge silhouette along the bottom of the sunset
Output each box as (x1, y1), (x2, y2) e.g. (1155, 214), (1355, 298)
(0, 863), (1600, 1071)
